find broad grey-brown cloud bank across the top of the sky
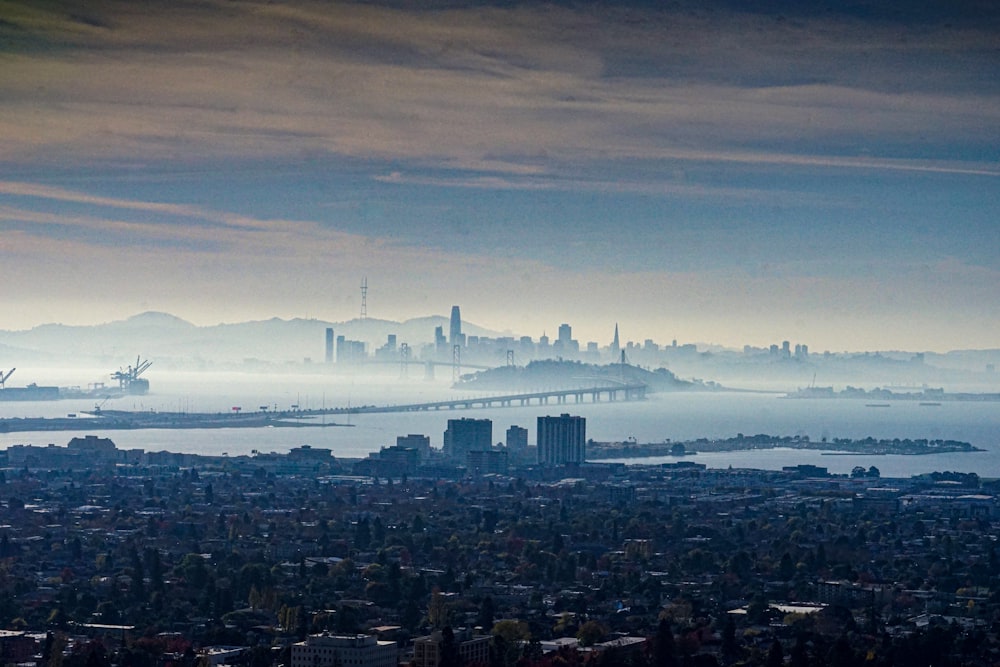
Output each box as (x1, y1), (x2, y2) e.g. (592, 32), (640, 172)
(0, 2), (1000, 174)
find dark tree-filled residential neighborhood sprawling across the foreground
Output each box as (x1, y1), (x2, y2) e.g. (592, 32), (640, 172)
(0, 436), (1000, 667)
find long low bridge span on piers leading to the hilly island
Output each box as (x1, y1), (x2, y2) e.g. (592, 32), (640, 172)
(320, 384), (646, 415)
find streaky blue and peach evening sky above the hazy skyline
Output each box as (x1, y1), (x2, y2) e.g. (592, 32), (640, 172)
(0, 0), (1000, 351)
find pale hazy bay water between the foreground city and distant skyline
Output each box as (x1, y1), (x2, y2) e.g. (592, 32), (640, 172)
(0, 372), (1000, 478)
